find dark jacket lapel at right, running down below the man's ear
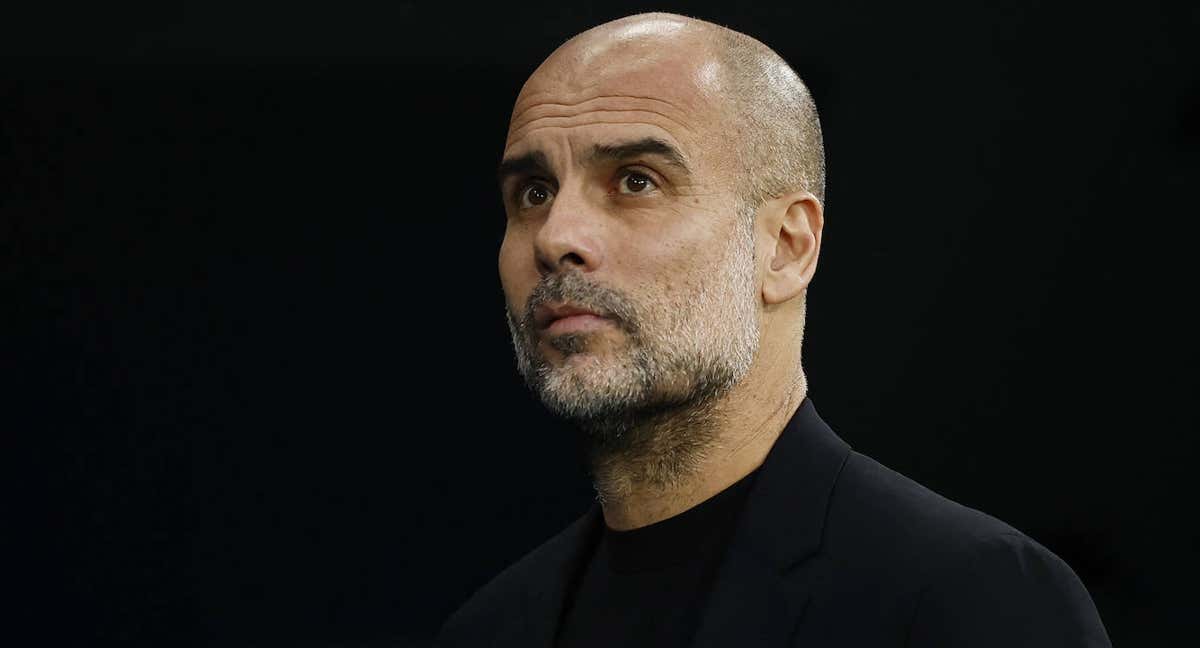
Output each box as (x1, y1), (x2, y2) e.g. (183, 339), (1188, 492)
(692, 398), (850, 648)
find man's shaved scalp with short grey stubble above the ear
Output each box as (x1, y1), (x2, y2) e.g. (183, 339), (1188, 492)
(514, 13), (826, 209)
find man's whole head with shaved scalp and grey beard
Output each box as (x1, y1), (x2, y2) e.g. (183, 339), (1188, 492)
(499, 14), (823, 456)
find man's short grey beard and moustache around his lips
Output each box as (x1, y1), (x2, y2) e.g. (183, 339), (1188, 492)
(506, 211), (758, 492)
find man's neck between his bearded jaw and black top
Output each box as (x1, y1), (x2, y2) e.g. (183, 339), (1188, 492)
(588, 372), (808, 530)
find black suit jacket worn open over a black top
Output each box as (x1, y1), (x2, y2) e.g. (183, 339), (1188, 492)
(439, 400), (1110, 648)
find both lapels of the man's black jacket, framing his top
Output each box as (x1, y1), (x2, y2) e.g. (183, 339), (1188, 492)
(518, 398), (850, 648)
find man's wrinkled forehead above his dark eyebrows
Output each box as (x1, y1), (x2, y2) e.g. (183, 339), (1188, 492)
(505, 34), (721, 166)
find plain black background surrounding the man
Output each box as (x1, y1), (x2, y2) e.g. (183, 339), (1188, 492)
(0, 2), (1200, 647)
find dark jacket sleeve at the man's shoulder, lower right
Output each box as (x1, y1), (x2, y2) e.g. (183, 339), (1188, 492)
(907, 533), (1111, 648)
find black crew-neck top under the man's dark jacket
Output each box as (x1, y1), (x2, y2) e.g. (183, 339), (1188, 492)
(557, 470), (757, 648)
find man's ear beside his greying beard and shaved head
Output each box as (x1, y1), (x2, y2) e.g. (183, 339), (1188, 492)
(760, 191), (824, 305)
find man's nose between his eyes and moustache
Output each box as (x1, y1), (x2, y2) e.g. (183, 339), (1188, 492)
(534, 187), (602, 276)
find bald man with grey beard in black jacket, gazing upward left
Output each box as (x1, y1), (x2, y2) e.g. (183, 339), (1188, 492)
(439, 13), (1109, 647)
